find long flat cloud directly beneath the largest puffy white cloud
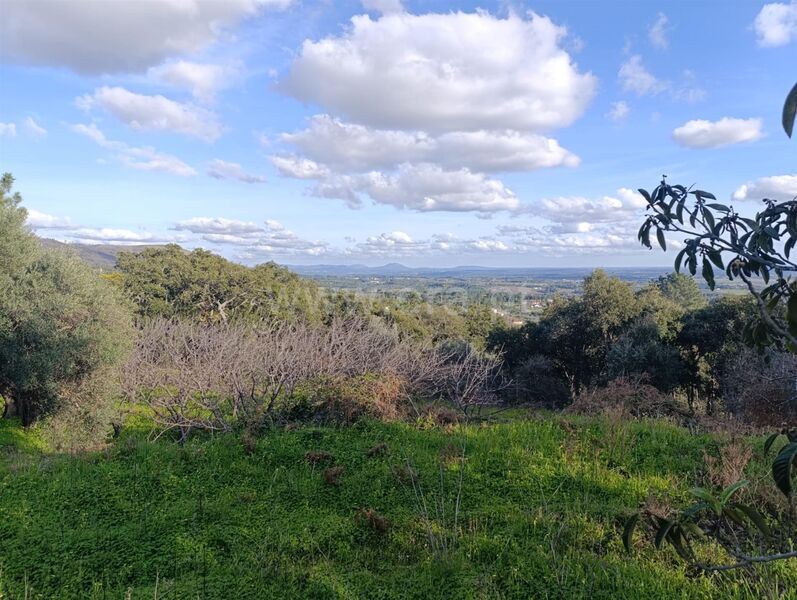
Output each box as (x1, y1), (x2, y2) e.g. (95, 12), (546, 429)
(282, 115), (580, 172)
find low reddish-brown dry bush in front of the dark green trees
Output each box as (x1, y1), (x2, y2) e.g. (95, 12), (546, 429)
(567, 377), (684, 418)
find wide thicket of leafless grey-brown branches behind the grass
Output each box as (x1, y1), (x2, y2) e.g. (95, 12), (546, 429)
(122, 319), (502, 441)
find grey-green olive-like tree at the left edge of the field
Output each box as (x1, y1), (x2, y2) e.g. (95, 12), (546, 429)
(0, 174), (132, 444)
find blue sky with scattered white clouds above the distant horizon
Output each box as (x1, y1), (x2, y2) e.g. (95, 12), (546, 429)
(0, 0), (797, 266)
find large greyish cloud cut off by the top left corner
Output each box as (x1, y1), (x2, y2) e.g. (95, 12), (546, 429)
(0, 0), (291, 75)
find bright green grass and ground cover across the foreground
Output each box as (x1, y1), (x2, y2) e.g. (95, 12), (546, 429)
(0, 416), (797, 600)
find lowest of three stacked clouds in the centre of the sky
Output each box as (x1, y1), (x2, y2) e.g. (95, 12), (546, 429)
(313, 163), (520, 213)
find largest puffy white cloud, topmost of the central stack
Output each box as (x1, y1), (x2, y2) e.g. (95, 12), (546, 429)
(281, 12), (597, 133)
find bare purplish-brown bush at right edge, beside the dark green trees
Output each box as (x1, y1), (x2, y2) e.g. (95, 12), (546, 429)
(722, 349), (797, 426)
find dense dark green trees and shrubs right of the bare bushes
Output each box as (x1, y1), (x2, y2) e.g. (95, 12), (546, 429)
(487, 271), (794, 424)
